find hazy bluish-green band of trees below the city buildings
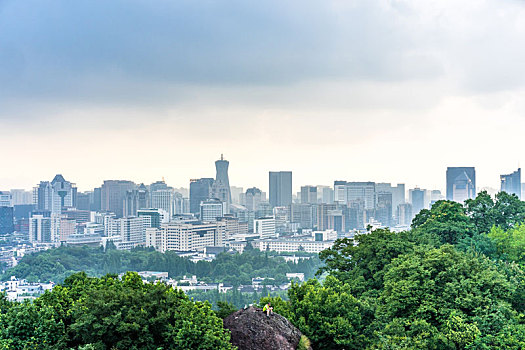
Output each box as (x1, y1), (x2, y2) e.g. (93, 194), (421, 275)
(2, 246), (320, 285)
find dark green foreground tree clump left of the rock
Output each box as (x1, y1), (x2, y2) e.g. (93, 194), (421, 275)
(0, 272), (232, 350)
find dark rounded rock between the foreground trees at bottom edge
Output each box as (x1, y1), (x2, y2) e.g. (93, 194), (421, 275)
(224, 307), (310, 350)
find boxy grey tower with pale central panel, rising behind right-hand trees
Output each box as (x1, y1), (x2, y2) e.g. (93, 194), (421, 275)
(446, 167), (476, 202)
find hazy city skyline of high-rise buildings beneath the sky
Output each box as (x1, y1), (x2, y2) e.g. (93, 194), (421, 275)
(0, 155), (522, 266)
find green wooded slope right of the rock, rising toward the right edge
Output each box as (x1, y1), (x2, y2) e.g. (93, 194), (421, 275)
(268, 192), (525, 349)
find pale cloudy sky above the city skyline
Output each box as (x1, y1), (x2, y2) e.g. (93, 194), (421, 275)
(0, 0), (525, 190)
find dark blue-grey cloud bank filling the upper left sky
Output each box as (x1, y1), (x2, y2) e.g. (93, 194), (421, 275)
(0, 0), (442, 110)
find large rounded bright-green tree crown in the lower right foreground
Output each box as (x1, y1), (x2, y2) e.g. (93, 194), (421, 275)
(376, 245), (517, 349)
